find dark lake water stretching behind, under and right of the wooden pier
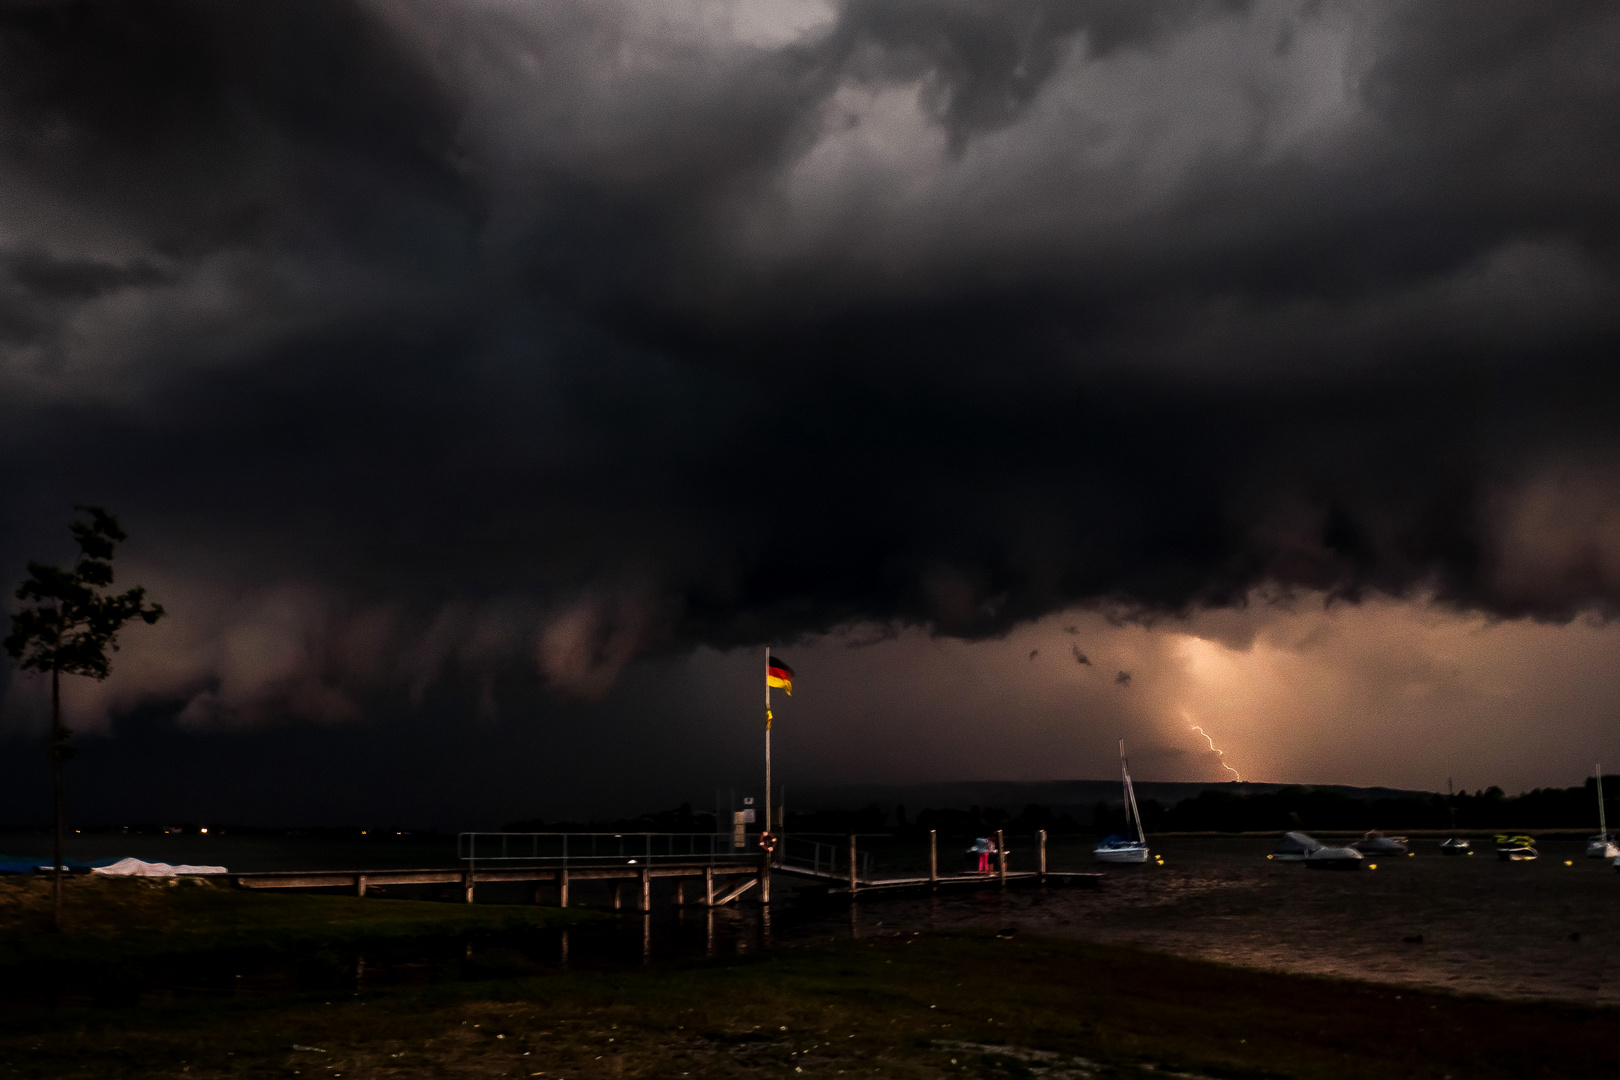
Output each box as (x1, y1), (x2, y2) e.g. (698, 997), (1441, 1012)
(0, 834), (1620, 1006)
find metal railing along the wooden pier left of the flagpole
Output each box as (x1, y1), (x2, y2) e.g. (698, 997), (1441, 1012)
(455, 832), (760, 866)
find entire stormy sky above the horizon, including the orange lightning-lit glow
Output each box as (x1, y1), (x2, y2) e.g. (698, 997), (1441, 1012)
(0, 0), (1620, 824)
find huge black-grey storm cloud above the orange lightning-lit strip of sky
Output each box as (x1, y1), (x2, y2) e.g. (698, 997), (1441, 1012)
(0, 0), (1620, 717)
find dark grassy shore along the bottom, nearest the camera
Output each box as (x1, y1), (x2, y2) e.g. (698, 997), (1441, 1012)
(0, 891), (1620, 1080)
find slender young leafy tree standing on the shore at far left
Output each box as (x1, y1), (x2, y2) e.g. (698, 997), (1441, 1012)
(5, 507), (164, 931)
